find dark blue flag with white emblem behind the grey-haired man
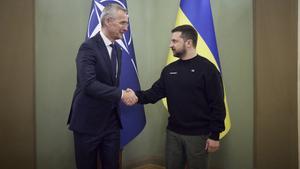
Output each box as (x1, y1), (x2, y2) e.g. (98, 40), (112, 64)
(86, 0), (146, 148)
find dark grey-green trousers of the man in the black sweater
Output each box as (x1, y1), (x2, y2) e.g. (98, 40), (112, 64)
(166, 130), (208, 169)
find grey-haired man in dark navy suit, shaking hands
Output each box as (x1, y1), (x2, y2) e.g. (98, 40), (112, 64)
(68, 4), (136, 169)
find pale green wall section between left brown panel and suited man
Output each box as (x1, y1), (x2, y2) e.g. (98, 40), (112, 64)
(35, 0), (91, 169)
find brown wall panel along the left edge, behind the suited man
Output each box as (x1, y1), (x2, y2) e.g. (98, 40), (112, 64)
(0, 0), (35, 169)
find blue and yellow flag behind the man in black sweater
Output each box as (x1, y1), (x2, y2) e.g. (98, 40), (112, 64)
(164, 0), (231, 138)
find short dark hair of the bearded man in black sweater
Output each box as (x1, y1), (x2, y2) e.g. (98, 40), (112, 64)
(171, 25), (198, 48)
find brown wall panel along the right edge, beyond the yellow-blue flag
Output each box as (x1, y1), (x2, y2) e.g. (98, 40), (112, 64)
(254, 0), (298, 169)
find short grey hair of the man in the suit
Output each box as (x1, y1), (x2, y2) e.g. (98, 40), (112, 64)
(100, 3), (128, 26)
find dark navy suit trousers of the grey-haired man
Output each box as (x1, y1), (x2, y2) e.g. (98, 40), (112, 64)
(73, 127), (120, 169)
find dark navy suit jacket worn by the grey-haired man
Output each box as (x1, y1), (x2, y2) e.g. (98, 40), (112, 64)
(68, 33), (122, 134)
